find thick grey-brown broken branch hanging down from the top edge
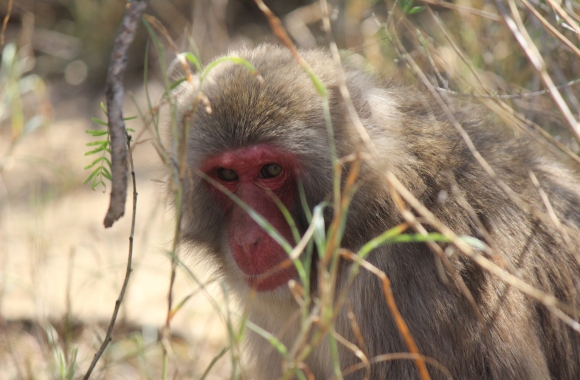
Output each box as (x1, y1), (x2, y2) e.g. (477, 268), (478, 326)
(104, 0), (149, 228)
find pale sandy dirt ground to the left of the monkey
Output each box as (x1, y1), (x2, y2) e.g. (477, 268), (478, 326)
(0, 84), (236, 379)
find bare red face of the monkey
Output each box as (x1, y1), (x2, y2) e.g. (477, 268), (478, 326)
(201, 144), (297, 291)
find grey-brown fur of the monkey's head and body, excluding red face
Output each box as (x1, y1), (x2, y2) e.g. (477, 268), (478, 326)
(178, 45), (580, 380)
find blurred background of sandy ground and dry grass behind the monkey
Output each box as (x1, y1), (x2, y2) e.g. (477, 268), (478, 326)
(0, 0), (580, 379)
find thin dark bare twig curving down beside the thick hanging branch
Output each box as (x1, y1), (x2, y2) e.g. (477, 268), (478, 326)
(83, 135), (137, 380)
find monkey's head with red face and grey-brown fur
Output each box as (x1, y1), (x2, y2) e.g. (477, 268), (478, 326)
(177, 45), (360, 292)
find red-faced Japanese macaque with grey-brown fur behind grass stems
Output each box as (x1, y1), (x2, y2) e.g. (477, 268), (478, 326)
(176, 45), (580, 380)
